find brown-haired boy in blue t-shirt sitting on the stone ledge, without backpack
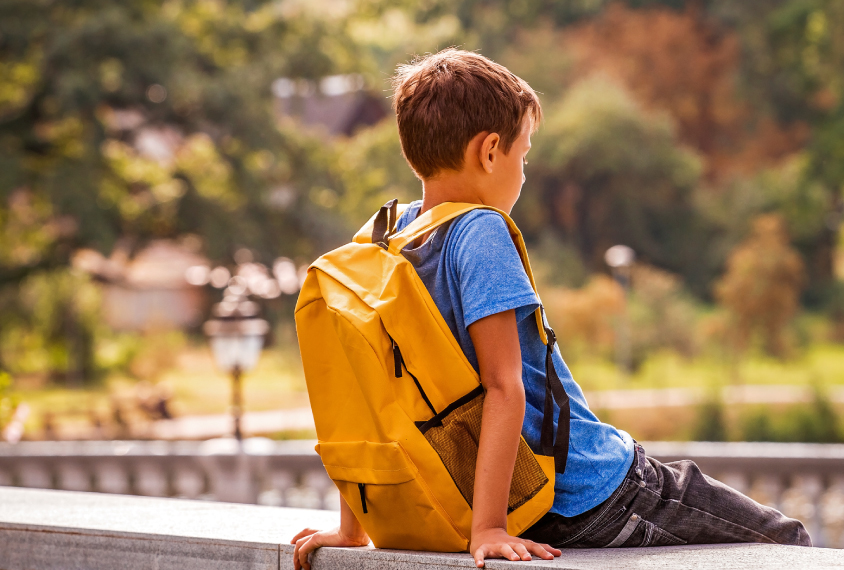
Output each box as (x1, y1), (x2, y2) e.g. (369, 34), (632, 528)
(292, 49), (811, 570)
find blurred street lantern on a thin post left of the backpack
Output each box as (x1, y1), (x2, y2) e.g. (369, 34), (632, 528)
(203, 294), (269, 441)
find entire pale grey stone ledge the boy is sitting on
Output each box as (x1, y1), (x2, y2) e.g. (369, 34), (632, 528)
(0, 487), (844, 570)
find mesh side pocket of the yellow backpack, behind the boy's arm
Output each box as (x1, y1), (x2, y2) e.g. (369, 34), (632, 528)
(419, 387), (548, 514)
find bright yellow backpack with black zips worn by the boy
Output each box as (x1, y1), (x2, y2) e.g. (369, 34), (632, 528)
(296, 200), (569, 552)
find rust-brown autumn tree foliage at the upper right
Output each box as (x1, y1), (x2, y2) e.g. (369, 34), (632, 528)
(566, 4), (805, 177)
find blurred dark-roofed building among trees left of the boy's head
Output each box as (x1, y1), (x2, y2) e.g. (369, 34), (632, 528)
(272, 74), (389, 136)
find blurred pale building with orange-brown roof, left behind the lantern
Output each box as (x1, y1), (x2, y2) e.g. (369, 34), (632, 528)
(74, 240), (208, 331)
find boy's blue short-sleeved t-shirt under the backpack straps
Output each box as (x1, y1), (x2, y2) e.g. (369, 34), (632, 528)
(398, 201), (633, 517)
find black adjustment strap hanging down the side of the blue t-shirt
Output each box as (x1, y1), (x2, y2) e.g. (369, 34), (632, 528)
(539, 316), (571, 473)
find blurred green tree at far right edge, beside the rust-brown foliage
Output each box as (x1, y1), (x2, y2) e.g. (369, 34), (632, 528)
(709, 0), (844, 298)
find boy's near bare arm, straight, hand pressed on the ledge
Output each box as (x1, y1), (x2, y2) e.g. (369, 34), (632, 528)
(469, 310), (561, 567)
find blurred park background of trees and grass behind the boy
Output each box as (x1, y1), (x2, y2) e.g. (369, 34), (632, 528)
(0, 0), (844, 545)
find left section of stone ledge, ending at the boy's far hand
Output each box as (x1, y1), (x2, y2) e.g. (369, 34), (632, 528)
(0, 487), (338, 570)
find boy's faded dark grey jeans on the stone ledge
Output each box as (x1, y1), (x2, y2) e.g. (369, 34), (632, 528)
(521, 444), (812, 548)
